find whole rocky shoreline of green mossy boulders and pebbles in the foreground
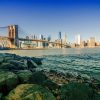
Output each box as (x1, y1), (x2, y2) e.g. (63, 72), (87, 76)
(0, 53), (100, 100)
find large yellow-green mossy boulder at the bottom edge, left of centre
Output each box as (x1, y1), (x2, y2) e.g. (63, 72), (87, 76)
(5, 84), (56, 100)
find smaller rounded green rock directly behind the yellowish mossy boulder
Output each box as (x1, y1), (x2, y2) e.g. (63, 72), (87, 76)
(16, 70), (33, 83)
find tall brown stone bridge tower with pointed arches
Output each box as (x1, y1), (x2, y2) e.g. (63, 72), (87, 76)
(8, 25), (19, 48)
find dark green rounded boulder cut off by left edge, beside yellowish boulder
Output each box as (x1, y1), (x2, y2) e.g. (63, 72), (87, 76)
(0, 71), (18, 93)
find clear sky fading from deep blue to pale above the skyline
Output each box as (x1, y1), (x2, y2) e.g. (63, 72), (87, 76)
(0, 0), (100, 42)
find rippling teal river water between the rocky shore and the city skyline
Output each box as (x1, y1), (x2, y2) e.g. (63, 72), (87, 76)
(0, 48), (100, 78)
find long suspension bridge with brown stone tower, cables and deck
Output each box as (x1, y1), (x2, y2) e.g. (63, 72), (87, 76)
(0, 25), (70, 49)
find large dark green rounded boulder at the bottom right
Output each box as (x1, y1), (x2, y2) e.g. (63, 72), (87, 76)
(60, 82), (95, 100)
